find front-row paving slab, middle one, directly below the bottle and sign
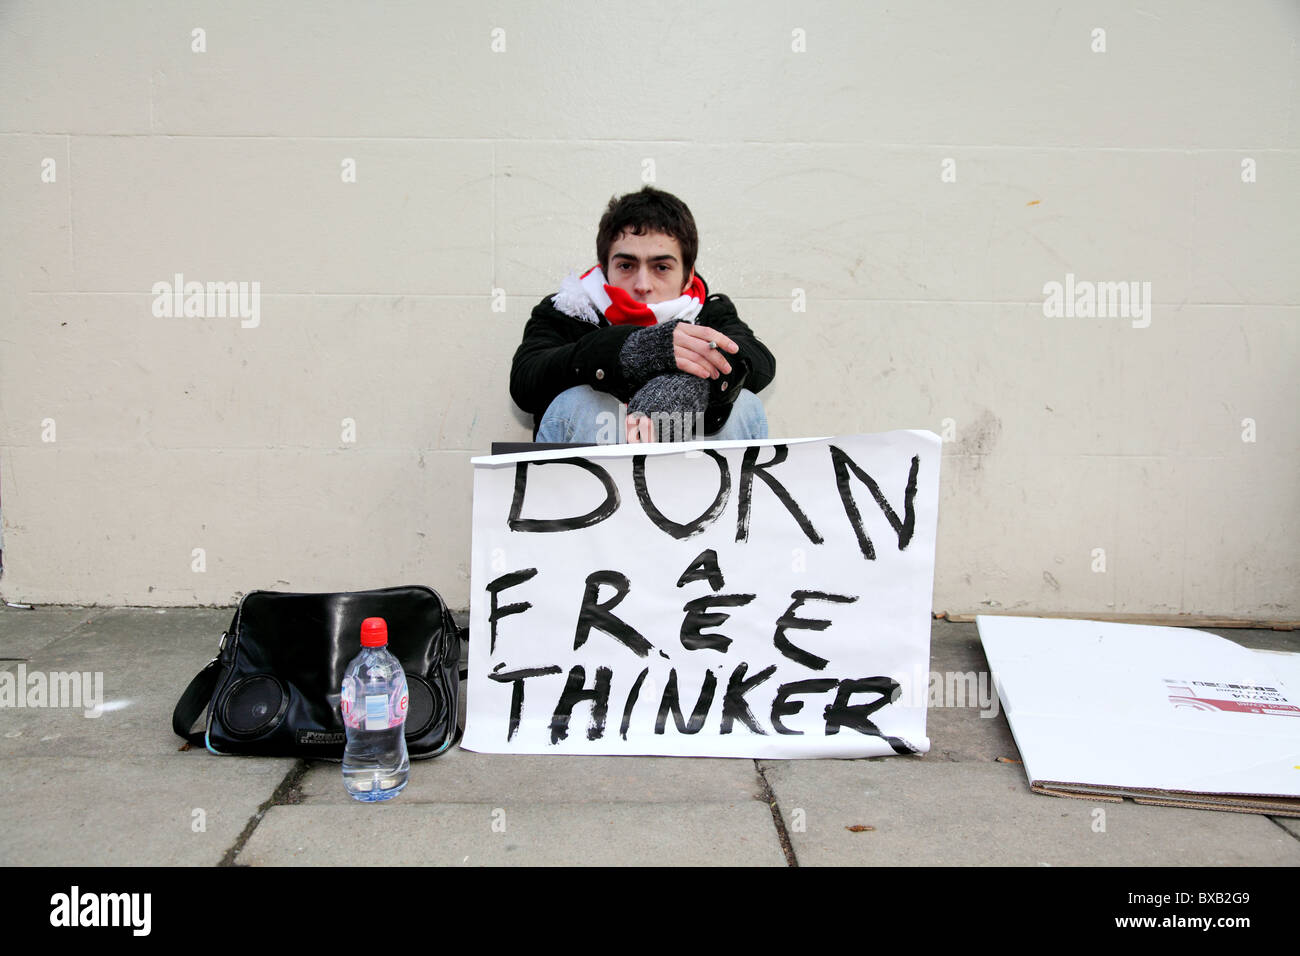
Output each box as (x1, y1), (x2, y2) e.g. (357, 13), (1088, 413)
(235, 793), (785, 866)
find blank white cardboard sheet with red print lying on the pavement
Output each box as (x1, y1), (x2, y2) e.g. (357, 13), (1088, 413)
(976, 615), (1300, 809)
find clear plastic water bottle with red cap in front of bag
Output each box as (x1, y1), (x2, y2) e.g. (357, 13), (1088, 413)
(341, 618), (411, 803)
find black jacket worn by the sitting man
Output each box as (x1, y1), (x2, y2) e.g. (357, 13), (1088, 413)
(510, 278), (776, 436)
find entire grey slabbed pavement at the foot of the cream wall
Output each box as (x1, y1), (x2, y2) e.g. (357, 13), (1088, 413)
(0, 607), (1300, 865)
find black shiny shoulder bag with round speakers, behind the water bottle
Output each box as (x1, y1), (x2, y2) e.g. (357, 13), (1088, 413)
(172, 585), (462, 760)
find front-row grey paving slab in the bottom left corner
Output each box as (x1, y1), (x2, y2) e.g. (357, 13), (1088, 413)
(0, 752), (296, 866)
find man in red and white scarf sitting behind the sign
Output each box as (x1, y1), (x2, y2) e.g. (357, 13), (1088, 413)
(510, 186), (776, 445)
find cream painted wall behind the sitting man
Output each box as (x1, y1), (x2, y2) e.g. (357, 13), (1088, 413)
(0, 0), (1300, 619)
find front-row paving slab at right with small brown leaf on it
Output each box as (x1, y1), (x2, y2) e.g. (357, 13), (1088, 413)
(762, 757), (1300, 866)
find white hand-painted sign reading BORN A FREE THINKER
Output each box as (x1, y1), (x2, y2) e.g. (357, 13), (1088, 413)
(462, 431), (940, 757)
